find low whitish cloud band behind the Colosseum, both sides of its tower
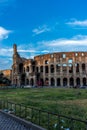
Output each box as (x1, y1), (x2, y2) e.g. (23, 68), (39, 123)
(0, 35), (87, 69)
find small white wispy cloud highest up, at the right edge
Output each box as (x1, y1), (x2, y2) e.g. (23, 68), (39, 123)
(66, 19), (87, 27)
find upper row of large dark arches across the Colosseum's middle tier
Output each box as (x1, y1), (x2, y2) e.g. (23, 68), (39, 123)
(19, 63), (86, 73)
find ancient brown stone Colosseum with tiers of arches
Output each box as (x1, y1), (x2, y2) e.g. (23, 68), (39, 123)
(12, 44), (87, 87)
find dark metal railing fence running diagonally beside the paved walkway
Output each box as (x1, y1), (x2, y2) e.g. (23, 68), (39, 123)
(0, 101), (87, 130)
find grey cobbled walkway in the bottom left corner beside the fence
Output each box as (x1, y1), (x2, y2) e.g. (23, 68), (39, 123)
(0, 112), (30, 130)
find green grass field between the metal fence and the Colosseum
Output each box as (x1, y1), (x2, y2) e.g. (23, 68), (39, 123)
(0, 88), (87, 120)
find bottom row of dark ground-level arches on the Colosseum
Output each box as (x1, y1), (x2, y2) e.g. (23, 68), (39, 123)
(26, 77), (87, 86)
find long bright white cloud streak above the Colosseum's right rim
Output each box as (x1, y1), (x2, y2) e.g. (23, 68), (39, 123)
(42, 35), (87, 47)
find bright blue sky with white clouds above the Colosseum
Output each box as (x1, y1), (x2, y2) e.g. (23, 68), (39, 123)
(0, 0), (87, 70)
